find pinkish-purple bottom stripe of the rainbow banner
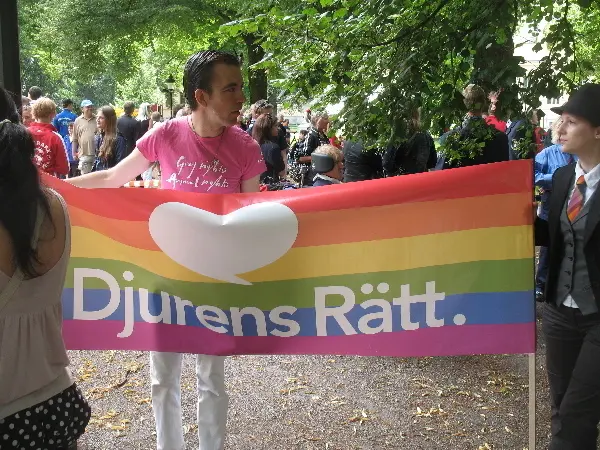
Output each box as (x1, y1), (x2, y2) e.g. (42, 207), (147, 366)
(63, 320), (536, 357)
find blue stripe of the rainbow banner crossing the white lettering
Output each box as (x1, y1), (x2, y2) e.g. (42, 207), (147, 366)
(63, 289), (535, 336)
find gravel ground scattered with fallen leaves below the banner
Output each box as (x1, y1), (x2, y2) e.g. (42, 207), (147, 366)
(70, 308), (549, 450)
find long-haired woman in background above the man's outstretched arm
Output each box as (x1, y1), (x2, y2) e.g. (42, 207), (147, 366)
(93, 106), (127, 172)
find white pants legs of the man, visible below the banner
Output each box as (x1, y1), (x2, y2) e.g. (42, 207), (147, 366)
(150, 352), (229, 450)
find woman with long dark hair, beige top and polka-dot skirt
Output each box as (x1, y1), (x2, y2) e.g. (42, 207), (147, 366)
(0, 88), (90, 449)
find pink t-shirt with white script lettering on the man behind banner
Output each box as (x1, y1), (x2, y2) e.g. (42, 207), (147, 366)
(137, 117), (267, 194)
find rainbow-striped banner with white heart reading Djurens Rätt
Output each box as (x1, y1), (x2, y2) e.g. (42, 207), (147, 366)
(55, 161), (535, 357)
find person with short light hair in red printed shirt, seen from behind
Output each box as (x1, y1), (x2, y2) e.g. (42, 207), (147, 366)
(29, 97), (69, 178)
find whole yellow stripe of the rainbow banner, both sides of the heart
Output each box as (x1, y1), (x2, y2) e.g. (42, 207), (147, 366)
(72, 225), (533, 282)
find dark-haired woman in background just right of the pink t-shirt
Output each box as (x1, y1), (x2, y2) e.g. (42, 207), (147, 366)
(252, 114), (285, 184)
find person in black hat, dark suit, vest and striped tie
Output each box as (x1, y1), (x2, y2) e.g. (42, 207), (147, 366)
(535, 84), (600, 450)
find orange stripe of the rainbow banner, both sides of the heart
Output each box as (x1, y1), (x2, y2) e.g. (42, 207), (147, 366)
(70, 193), (532, 250)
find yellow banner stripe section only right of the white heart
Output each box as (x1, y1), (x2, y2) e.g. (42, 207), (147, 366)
(241, 225), (533, 281)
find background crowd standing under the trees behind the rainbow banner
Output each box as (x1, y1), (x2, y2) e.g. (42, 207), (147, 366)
(17, 75), (551, 190)
